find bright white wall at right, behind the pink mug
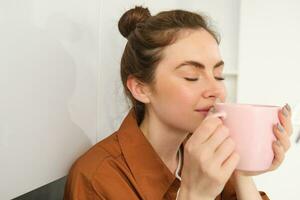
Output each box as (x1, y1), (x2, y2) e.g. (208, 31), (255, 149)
(237, 0), (300, 200)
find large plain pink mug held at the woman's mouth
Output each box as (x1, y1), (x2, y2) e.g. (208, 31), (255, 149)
(215, 103), (280, 171)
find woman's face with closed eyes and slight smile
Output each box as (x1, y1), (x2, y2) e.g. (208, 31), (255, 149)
(147, 29), (226, 132)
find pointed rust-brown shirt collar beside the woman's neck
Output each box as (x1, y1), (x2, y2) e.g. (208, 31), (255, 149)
(118, 109), (180, 199)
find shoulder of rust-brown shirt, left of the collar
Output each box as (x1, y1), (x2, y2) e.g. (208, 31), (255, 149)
(65, 132), (137, 199)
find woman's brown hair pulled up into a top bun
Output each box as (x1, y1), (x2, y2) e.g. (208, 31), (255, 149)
(118, 6), (219, 124)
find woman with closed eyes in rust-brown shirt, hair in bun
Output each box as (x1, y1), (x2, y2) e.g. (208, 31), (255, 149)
(65, 7), (292, 200)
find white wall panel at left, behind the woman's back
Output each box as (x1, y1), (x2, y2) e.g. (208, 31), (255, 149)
(0, 0), (100, 200)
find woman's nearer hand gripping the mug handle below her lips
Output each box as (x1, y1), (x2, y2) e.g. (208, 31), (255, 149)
(178, 110), (239, 200)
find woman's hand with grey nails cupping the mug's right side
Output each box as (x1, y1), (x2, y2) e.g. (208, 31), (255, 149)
(235, 104), (293, 176)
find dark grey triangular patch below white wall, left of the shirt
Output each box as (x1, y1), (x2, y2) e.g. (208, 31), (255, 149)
(13, 176), (67, 200)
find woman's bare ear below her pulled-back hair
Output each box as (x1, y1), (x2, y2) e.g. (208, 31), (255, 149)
(126, 76), (151, 104)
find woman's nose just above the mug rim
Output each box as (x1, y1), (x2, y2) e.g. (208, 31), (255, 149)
(202, 79), (226, 99)
